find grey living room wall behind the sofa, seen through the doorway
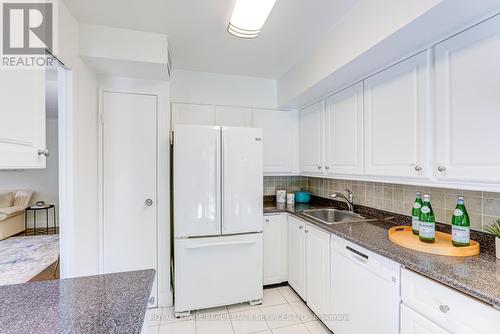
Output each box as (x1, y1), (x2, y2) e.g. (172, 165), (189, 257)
(0, 119), (59, 227)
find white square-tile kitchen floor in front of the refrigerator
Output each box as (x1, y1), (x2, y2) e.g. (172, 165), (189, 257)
(146, 286), (331, 334)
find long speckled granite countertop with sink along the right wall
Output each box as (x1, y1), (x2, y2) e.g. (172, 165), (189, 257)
(264, 203), (500, 309)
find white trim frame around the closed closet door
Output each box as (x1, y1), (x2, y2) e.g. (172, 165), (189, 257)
(98, 77), (173, 307)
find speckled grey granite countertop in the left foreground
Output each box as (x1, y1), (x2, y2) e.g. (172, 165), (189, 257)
(0, 269), (155, 334)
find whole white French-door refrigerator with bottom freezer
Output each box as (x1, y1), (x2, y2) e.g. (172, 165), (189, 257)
(173, 125), (263, 315)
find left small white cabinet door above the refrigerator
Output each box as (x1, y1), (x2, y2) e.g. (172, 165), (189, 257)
(172, 103), (215, 128)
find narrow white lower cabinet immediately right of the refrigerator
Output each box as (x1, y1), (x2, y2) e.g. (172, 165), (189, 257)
(264, 213), (288, 285)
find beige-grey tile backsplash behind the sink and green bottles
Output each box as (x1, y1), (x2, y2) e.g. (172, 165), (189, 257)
(264, 176), (500, 230)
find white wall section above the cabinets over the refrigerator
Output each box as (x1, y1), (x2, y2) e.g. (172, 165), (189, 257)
(170, 69), (276, 108)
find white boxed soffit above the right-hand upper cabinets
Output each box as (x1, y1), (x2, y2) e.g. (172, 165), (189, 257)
(277, 0), (500, 107)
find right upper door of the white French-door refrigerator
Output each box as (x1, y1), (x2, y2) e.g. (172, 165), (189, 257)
(222, 127), (264, 234)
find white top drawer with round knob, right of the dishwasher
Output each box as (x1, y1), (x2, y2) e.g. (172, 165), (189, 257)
(401, 269), (500, 334)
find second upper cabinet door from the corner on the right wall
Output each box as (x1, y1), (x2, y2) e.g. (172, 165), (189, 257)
(325, 82), (363, 174)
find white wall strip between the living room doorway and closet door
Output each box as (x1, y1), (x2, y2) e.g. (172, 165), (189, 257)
(56, 1), (99, 278)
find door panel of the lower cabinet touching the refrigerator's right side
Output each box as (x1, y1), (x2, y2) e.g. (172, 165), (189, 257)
(264, 214), (283, 285)
